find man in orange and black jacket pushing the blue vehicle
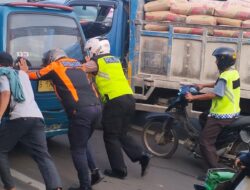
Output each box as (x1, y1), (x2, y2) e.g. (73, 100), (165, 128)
(20, 49), (101, 190)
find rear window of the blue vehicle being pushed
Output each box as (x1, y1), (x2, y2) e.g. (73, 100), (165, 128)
(7, 13), (83, 68)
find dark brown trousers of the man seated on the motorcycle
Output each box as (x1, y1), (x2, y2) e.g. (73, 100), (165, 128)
(200, 117), (235, 168)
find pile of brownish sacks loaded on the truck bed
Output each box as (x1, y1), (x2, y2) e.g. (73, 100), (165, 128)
(144, 0), (250, 37)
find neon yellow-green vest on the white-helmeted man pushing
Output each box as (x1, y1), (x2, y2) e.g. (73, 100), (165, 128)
(95, 55), (133, 102)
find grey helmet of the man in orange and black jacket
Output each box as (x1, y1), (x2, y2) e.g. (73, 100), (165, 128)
(43, 48), (67, 66)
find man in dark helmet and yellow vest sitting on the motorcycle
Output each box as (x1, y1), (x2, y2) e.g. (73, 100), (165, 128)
(186, 47), (240, 168)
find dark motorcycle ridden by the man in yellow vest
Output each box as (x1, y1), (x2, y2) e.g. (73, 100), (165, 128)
(142, 85), (250, 165)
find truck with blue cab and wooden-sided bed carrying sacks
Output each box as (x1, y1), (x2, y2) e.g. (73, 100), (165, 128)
(38, 0), (250, 117)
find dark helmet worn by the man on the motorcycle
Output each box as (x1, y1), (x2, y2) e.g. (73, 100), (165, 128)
(212, 47), (236, 71)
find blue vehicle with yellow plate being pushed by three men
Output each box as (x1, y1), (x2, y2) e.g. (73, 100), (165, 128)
(0, 2), (85, 138)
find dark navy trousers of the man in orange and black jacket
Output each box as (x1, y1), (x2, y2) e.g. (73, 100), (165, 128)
(68, 105), (101, 189)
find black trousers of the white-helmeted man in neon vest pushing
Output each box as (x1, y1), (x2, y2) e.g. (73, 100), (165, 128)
(102, 95), (143, 171)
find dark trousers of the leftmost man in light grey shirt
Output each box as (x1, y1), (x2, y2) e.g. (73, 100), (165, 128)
(0, 118), (62, 190)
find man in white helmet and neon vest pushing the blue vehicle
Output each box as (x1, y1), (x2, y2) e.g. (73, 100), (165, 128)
(84, 37), (150, 179)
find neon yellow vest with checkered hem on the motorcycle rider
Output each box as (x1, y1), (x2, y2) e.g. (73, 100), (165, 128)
(210, 69), (240, 118)
